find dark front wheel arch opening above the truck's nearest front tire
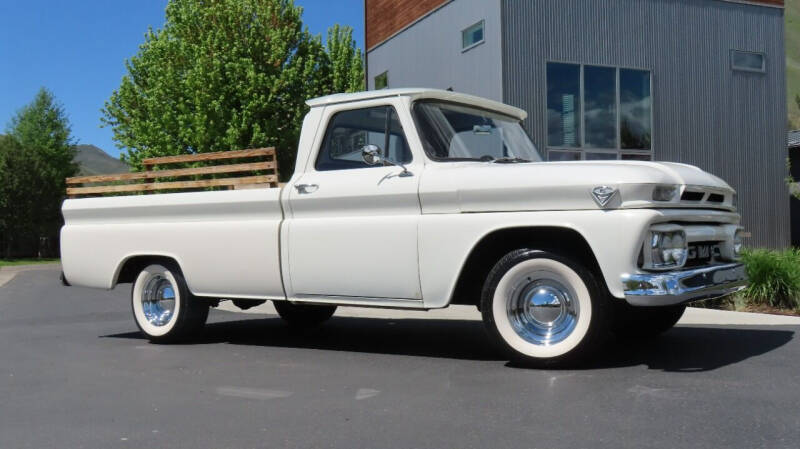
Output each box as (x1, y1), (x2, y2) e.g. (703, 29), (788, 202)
(449, 226), (608, 305)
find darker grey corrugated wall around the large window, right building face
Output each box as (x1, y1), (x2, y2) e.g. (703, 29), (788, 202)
(501, 0), (790, 247)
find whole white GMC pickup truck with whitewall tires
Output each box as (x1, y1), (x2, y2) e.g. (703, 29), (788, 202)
(61, 89), (747, 364)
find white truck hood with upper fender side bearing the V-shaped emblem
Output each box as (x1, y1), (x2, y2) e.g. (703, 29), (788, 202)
(420, 161), (735, 213)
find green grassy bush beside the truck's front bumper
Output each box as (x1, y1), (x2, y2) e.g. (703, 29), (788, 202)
(742, 248), (800, 310)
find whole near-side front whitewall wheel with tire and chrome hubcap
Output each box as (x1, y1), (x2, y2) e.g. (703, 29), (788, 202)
(481, 249), (608, 367)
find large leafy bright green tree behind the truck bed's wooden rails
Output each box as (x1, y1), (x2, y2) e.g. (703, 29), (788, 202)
(101, 0), (363, 176)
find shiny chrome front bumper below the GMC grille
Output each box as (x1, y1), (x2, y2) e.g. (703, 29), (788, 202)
(622, 263), (747, 306)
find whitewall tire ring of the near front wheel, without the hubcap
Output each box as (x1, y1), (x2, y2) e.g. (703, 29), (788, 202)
(481, 249), (603, 363)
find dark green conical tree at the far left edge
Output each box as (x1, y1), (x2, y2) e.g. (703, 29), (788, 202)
(0, 88), (77, 257)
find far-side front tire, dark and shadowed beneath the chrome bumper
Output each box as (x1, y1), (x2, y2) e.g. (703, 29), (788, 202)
(613, 303), (686, 338)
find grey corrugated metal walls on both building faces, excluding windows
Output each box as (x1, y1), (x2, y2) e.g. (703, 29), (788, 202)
(365, 0), (790, 247)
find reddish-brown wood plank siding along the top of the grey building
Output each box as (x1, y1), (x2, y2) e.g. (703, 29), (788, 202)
(364, 0), (784, 51)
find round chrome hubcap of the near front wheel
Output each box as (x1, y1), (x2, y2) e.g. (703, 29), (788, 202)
(507, 278), (580, 346)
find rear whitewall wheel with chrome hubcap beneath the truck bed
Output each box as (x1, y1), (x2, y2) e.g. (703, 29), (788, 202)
(131, 263), (209, 343)
